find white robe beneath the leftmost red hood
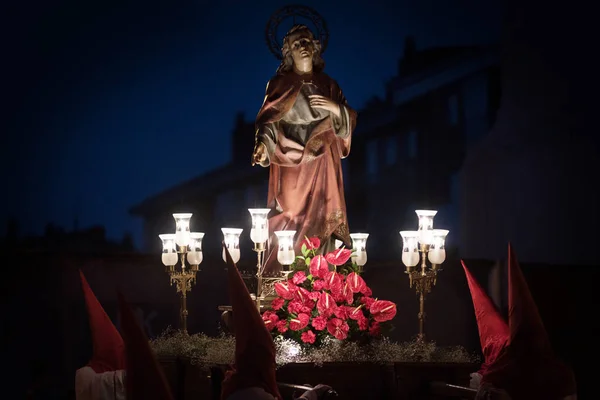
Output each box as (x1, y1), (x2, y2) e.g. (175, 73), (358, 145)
(75, 366), (126, 400)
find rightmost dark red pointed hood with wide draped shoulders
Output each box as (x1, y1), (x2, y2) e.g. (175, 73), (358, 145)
(466, 245), (576, 400)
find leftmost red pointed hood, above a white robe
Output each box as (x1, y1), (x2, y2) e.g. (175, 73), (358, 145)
(79, 270), (125, 373)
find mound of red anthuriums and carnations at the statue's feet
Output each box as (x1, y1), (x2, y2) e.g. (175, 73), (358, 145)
(262, 237), (396, 346)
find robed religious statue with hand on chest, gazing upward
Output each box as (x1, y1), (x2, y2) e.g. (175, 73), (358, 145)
(252, 7), (356, 275)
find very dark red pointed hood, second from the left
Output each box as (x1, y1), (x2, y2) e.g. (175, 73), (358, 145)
(118, 292), (173, 400)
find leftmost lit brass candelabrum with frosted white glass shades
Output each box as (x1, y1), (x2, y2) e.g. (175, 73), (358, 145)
(159, 213), (204, 333)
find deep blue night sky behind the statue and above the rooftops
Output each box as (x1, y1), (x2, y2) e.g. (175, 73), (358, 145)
(0, 0), (501, 248)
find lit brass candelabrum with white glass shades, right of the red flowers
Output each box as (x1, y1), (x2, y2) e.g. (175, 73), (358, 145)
(400, 210), (449, 341)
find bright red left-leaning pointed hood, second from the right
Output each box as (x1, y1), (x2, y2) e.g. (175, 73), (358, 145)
(461, 260), (509, 375)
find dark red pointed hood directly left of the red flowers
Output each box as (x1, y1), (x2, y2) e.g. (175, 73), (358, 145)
(221, 248), (281, 399)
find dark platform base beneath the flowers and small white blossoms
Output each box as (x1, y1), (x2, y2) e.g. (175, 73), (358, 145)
(160, 358), (479, 400)
